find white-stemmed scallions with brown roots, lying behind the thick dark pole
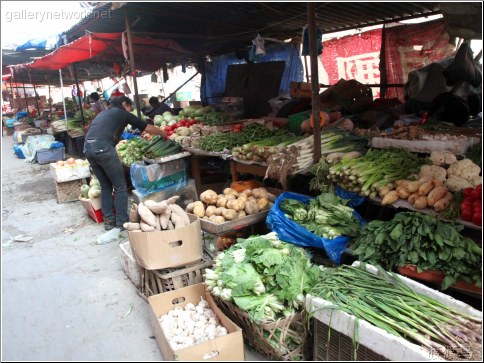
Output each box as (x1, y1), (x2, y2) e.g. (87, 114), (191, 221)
(266, 128), (368, 189)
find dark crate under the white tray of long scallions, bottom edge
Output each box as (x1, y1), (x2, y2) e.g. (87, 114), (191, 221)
(314, 319), (388, 361)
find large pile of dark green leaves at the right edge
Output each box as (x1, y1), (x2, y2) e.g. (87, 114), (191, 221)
(351, 212), (482, 289)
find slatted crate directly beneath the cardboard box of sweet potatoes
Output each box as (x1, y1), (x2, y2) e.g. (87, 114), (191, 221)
(140, 250), (213, 297)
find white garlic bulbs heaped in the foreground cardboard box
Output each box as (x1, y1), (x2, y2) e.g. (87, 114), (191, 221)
(159, 298), (228, 352)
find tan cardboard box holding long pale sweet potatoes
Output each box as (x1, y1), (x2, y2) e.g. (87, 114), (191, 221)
(128, 215), (203, 270)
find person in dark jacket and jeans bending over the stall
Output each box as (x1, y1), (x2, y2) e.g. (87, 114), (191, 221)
(84, 96), (164, 230)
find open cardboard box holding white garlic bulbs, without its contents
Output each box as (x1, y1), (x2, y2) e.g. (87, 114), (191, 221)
(148, 284), (244, 362)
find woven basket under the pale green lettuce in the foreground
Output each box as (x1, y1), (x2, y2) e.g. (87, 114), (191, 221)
(214, 296), (308, 361)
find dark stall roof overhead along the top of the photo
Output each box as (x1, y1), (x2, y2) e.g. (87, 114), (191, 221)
(66, 2), (446, 56)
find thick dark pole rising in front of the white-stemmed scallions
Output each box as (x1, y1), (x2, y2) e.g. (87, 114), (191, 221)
(307, 2), (321, 164)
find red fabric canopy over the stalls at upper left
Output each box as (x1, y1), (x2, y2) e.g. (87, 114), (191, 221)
(15, 33), (190, 72)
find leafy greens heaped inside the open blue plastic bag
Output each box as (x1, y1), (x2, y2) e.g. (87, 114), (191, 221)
(280, 191), (360, 239)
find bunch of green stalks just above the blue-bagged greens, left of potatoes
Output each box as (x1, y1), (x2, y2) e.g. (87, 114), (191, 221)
(312, 149), (429, 198)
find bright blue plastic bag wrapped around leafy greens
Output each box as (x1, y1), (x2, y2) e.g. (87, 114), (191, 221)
(266, 192), (364, 264)
